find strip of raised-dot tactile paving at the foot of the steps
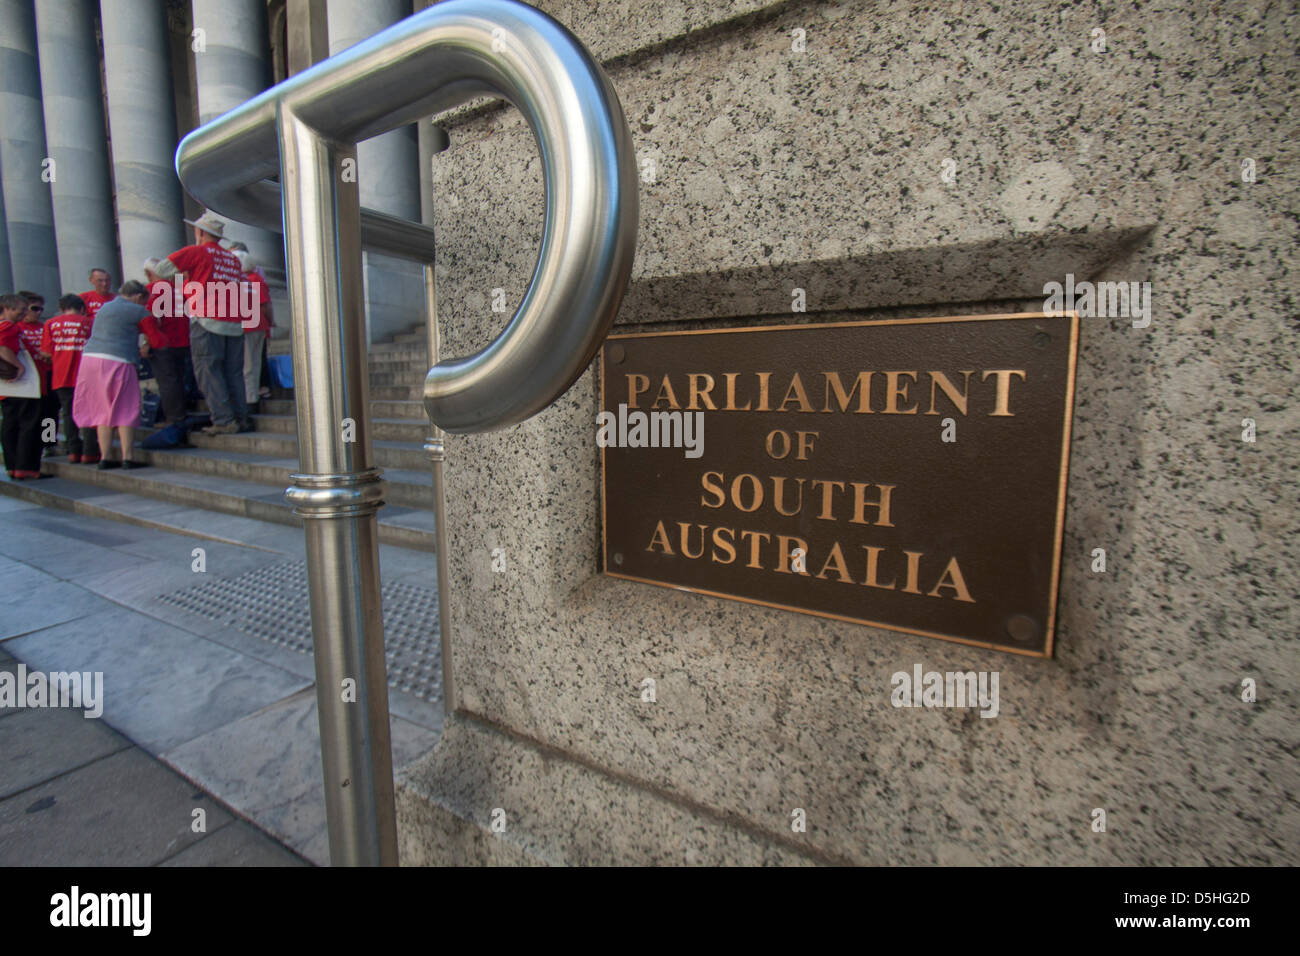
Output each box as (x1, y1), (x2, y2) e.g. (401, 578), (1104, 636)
(160, 561), (442, 702)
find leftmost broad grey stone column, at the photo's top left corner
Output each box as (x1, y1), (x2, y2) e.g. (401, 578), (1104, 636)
(0, 0), (60, 300)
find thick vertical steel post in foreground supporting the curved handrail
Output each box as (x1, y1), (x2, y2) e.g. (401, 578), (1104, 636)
(278, 108), (398, 866)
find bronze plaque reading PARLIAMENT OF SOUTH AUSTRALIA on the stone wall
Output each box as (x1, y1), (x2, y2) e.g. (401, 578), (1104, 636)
(597, 313), (1079, 657)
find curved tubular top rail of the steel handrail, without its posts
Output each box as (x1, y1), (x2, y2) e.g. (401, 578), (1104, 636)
(177, 0), (637, 432)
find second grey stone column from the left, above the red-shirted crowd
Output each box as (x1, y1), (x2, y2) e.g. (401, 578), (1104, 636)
(36, 0), (118, 291)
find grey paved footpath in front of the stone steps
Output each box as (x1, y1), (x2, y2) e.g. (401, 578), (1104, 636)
(0, 479), (442, 865)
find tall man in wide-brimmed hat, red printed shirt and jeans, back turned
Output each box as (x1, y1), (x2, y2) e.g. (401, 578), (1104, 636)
(156, 212), (248, 434)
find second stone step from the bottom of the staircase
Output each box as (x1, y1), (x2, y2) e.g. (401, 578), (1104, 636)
(57, 436), (433, 509)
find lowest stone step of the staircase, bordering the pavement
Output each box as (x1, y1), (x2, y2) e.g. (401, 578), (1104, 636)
(13, 458), (437, 551)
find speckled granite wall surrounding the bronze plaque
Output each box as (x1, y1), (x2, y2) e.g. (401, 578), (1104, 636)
(399, 0), (1300, 865)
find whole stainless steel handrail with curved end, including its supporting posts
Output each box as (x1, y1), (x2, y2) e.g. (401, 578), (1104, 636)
(176, 0), (637, 864)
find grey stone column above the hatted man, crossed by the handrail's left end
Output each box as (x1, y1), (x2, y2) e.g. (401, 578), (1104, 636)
(192, 0), (289, 290)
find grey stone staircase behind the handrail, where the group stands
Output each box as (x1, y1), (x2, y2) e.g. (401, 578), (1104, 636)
(0, 328), (434, 551)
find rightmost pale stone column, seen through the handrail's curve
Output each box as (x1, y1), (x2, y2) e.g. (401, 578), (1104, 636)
(329, 0), (424, 341)
